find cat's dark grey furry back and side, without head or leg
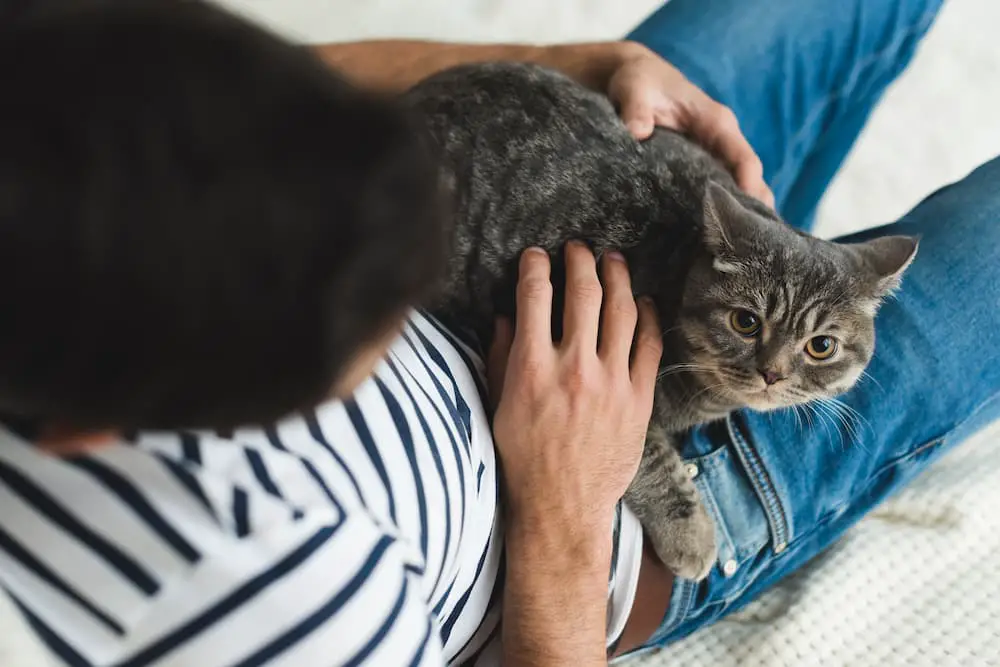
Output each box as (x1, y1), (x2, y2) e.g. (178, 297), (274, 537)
(404, 63), (728, 332)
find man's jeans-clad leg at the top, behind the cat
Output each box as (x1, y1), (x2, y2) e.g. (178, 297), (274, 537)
(628, 0), (942, 227)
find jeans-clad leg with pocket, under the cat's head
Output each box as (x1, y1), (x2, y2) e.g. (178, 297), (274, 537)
(657, 158), (1000, 642)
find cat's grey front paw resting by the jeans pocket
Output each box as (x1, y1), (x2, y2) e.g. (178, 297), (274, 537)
(647, 503), (718, 581)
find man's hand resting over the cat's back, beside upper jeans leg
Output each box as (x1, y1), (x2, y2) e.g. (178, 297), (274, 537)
(607, 43), (774, 207)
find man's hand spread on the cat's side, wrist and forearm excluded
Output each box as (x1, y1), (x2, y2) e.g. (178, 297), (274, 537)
(490, 242), (662, 531)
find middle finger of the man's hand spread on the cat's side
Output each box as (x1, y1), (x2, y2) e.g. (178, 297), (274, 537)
(563, 241), (603, 352)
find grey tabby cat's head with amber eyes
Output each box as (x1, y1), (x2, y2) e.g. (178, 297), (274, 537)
(676, 183), (917, 410)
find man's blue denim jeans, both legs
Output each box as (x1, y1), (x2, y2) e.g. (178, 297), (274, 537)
(630, 0), (1000, 645)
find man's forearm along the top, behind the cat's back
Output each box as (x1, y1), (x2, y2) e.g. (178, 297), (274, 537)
(314, 40), (640, 91)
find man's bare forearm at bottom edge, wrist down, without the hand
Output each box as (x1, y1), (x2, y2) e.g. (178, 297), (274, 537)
(502, 518), (611, 667)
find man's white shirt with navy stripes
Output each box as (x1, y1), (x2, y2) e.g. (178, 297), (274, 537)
(0, 313), (641, 667)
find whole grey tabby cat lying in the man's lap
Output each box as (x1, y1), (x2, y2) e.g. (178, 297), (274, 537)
(407, 63), (917, 579)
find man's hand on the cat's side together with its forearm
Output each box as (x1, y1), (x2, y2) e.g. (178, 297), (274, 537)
(489, 243), (662, 666)
